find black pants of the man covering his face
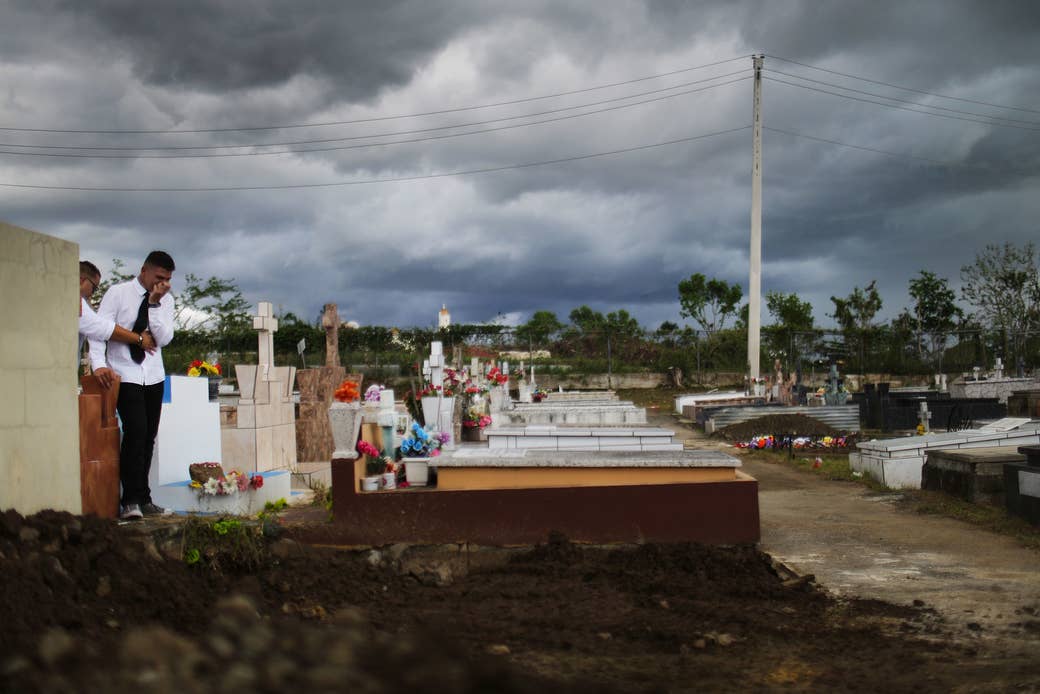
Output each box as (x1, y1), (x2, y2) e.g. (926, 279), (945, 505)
(115, 382), (163, 506)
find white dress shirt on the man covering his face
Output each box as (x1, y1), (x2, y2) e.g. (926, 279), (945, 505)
(90, 278), (174, 386)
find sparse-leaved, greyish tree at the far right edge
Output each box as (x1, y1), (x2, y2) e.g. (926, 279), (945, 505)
(961, 242), (1040, 356)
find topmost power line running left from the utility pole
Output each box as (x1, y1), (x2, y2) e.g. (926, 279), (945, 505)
(0, 53), (751, 135)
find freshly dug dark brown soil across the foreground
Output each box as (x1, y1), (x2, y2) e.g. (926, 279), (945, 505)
(0, 511), (994, 694)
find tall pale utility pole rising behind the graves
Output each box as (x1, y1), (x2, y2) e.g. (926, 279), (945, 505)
(748, 55), (765, 382)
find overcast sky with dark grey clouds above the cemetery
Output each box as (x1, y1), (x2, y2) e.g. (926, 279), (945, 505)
(0, 0), (1040, 329)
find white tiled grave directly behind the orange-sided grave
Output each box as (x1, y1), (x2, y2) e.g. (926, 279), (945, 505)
(487, 425), (682, 452)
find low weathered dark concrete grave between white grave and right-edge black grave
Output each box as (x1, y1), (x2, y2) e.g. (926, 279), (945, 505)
(921, 445), (1025, 506)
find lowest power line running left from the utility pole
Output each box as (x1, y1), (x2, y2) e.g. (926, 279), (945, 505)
(0, 125), (751, 192)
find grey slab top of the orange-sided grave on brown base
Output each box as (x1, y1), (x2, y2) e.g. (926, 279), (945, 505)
(430, 447), (740, 467)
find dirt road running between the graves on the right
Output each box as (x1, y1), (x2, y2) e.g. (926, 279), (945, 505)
(651, 415), (1040, 667)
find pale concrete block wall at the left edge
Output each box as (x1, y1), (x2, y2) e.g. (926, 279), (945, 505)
(0, 222), (82, 513)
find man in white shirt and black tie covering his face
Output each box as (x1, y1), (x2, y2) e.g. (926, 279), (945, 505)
(90, 251), (176, 519)
